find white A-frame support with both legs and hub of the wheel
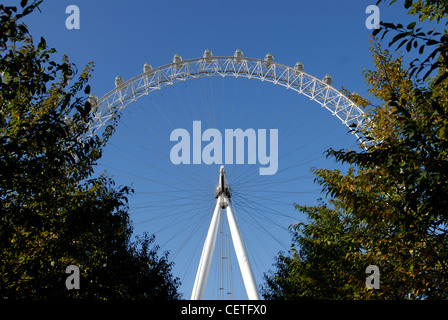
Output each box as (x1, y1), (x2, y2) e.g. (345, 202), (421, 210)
(191, 166), (260, 300)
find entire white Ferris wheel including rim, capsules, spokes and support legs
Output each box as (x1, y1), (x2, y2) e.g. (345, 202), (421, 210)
(89, 49), (367, 299)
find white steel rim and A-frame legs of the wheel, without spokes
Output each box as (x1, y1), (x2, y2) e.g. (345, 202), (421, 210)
(88, 49), (368, 300)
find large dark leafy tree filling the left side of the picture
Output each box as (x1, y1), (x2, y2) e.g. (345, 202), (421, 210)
(0, 0), (180, 299)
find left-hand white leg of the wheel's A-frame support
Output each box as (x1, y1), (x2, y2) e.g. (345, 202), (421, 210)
(191, 197), (221, 300)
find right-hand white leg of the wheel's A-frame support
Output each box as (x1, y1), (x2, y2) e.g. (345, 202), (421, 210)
(226, 198), (260, 300)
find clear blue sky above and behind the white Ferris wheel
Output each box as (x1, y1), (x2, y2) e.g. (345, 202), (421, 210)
(19, 0), (409, 299)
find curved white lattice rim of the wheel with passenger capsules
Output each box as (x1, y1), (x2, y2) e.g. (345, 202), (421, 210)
(88, 50), (368, 138)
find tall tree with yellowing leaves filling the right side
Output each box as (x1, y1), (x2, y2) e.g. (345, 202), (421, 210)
(264, 0), (448, 299)
